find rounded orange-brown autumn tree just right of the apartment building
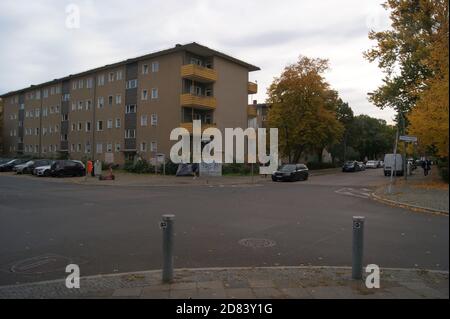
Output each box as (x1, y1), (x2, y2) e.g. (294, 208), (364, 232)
(267, 56), (343, 162)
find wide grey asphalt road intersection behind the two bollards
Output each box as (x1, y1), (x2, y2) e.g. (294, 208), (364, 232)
(0, 170), (449, 285)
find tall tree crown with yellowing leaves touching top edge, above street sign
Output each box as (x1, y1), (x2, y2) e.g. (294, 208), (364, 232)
(364, 0), (440, 121)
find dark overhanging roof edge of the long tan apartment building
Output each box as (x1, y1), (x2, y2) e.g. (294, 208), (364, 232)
(0, 42), (261, 98)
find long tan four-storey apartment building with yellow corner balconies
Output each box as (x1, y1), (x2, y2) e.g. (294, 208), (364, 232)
(1, 42), (259, 164)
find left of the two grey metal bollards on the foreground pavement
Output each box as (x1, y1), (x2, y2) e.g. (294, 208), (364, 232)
(160, 215), (175, 283)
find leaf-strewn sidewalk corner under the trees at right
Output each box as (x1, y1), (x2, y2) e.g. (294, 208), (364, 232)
(373, 168), (449, 215)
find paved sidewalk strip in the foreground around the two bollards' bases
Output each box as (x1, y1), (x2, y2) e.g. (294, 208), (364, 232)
(0, 267), (449, 299)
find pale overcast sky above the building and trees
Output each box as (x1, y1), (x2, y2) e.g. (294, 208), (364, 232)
(0, 0), (394, 122)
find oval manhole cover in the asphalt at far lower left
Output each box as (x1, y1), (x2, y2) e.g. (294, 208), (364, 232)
(11, 255), (72, 275)
